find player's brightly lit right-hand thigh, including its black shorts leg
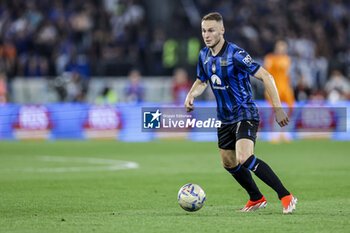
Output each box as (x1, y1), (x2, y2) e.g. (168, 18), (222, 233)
(235, 120), (259, 164)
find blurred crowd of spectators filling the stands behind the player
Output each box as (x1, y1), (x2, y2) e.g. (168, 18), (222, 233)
(0, 0), (350, 101)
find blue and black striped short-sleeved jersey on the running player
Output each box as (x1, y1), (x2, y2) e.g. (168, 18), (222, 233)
(197, 41), (260, 124)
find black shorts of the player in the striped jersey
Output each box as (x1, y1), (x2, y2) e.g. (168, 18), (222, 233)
(218, 120), (259, 150)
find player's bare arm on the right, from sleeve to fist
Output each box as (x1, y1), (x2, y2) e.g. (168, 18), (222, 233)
(254, 67), (289, 127)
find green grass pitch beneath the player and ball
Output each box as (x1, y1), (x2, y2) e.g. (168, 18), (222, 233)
(0, 140), (350, 233)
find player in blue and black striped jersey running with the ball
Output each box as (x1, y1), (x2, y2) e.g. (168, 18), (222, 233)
(185, 12), (297, 213)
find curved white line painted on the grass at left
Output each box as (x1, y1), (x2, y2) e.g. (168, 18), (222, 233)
(3, 156), (139, 172)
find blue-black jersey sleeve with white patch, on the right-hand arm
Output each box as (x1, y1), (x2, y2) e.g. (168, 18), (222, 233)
(233, 48), (260, 75)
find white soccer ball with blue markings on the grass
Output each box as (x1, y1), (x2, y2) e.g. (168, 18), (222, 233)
(177, 184), (205, 212)
